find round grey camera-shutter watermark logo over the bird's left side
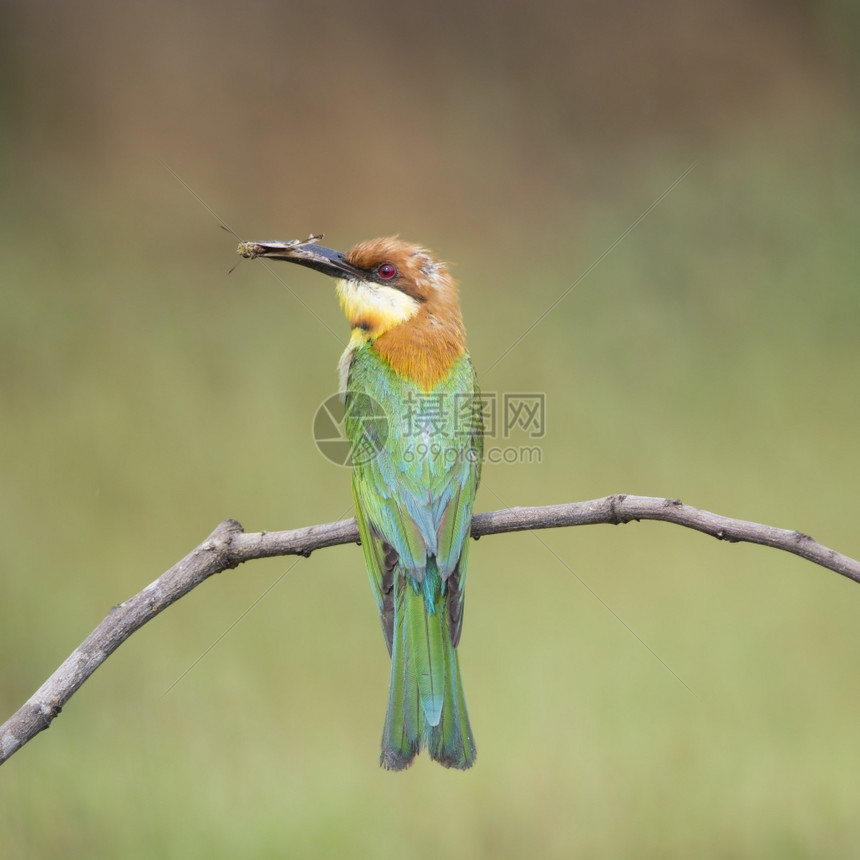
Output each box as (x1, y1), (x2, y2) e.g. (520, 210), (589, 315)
(313, 393), (389, 469)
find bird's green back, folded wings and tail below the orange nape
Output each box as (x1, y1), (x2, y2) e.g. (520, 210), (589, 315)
(346, 346), (482, 770)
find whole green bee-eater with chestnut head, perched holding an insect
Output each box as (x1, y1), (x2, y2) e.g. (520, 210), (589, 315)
(238, 235), (483, 771)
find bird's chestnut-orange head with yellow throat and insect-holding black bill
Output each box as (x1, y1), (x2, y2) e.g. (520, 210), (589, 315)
(239, 232), (465, 385)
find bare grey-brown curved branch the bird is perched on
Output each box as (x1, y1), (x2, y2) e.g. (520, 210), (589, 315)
(0, 495), (860, 764)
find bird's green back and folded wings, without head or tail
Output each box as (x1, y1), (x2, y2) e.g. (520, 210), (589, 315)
(347, 350), (482, 627)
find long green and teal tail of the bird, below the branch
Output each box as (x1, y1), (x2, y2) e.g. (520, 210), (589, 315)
(380, 559), (476, 770)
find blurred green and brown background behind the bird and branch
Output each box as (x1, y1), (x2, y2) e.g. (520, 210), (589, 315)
(0, 0), (860, 860)
